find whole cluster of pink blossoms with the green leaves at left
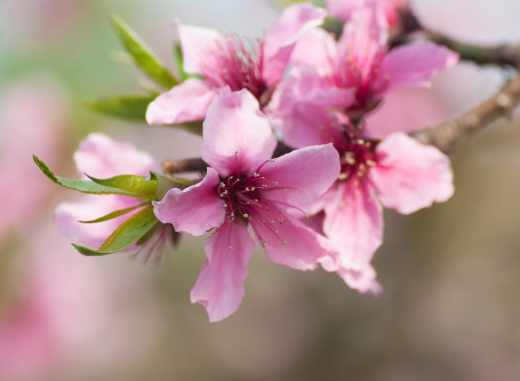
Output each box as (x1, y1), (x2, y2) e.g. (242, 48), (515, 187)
(36, 0), (458, 321)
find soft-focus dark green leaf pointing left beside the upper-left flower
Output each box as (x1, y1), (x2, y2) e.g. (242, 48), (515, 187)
(85, 95), (155, 122)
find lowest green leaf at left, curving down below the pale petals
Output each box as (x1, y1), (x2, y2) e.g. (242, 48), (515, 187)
(72, 205), (158, 255)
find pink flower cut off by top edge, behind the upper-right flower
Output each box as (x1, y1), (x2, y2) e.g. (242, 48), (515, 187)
(325, 0), (408, 25)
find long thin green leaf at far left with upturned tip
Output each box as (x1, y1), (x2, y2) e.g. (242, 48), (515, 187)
(33, 155), (155, 200)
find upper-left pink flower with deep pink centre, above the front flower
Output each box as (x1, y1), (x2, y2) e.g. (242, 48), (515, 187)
(146, 4), (325, 124)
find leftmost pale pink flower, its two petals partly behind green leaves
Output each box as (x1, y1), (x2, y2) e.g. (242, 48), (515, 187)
(55, 133), (159, 247)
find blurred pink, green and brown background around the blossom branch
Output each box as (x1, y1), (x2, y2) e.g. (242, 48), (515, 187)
(0, 0), (520, 381)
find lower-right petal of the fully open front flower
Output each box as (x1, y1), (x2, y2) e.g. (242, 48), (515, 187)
(250, 203), (338, 271)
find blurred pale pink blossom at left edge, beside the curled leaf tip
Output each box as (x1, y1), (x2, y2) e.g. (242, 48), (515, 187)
(0, 80), (67, 242)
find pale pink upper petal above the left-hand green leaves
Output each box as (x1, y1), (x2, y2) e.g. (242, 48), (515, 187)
(74, 133), (159, 178)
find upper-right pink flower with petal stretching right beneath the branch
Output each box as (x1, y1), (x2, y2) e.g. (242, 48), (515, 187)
(272, 2), (458, 148)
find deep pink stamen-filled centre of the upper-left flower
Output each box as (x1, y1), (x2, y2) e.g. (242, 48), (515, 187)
(204, 36), (267, 100)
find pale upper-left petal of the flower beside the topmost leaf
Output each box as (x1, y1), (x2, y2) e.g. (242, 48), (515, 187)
(174, 21), (223, 75)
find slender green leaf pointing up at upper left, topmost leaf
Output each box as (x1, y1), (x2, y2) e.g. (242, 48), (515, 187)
(110, 16), (179, 89)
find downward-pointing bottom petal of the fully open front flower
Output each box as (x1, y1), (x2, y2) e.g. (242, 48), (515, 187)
(191, 220), (255, 322)
